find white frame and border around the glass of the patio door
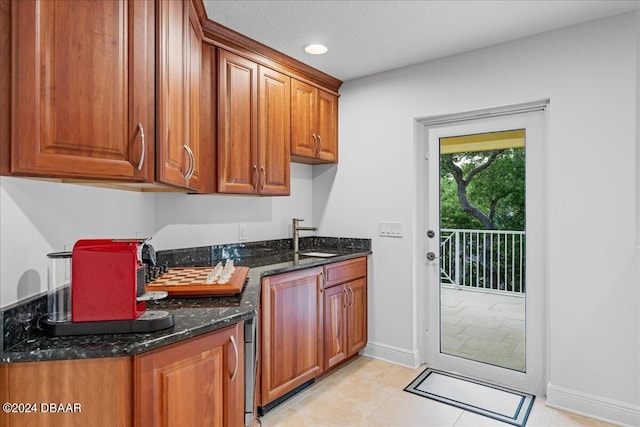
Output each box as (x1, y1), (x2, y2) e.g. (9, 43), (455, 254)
(414, 99), (549, 395)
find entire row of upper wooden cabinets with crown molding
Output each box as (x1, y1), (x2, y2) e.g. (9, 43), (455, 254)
(0, 0), (342, 191)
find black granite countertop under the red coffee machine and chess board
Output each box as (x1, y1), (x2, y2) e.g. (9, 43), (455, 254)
(0, 246), (372, 363)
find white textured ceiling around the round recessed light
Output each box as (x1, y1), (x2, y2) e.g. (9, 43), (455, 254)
(204, 0), (640, 81)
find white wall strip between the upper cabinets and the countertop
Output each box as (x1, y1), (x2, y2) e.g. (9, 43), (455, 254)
(0, 164), (313, 307)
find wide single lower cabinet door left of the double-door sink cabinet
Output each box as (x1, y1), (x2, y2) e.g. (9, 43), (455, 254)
(261, 267), (323, 405)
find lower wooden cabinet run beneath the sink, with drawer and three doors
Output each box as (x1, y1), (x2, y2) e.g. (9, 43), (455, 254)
(259, 257), (367, 407)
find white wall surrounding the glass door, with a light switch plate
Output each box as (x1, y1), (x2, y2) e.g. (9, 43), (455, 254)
(313, 14), (640, 424)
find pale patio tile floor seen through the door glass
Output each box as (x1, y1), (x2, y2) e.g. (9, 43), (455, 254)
(441, 287), (525, 371)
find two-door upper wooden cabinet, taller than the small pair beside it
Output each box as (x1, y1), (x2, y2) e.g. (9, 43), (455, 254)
(218, 49), (291, 195)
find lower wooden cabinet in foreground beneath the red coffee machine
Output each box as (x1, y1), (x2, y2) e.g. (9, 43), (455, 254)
(0, 322), (245, 427)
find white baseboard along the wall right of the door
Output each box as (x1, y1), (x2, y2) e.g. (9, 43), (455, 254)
(547, 383), (640, 426)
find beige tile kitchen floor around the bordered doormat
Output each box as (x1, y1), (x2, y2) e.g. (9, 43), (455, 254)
(260, 356), (611, 427)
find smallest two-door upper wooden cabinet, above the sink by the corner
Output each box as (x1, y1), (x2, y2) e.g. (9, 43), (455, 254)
(291, 79), (338, 164)
